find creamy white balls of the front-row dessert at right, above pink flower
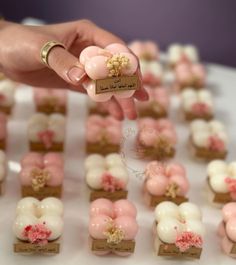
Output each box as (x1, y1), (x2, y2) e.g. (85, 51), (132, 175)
(155, 202), (205, 244)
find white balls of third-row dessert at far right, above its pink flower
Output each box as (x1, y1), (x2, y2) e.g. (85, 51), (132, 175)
(190, 119), (228, 147)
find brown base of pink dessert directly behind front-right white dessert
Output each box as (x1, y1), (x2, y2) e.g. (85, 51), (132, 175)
(143, 188), (188, 207)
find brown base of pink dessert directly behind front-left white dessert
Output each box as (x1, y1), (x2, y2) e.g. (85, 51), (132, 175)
(21, 185), (63, 200)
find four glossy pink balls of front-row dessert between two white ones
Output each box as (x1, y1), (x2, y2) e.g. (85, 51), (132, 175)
(89, 199), (138, 245)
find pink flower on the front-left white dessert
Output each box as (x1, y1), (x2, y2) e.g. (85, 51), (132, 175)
(22, 223), (52, 245)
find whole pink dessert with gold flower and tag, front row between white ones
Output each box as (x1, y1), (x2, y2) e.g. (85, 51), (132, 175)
(89, 198), (138, 256)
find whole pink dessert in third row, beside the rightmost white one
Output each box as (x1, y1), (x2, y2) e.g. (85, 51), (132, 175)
(137, 118), (177, 160)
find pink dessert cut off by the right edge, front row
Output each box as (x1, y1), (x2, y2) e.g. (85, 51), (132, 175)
(218, 202), (236, 258)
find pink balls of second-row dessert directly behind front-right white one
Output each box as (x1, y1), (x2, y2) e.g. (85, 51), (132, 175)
(144, 161), (189, 196)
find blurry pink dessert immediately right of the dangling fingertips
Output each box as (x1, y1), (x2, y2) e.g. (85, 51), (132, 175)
(137, 86), (170, 118)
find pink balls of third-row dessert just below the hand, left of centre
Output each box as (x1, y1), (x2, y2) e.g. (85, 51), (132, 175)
(86, 115), (122, 144)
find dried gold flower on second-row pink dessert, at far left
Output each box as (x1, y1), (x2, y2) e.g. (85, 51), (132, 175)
(31, 168), (51, 191)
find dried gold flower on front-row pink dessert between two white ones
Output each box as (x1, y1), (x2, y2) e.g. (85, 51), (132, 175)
(104, 221), (125, 245)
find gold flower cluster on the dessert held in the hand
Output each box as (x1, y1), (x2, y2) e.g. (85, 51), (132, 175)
(106, 54), (130, 77)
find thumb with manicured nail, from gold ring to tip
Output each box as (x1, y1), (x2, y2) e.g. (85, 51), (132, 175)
(48, 46), (86, 86)
